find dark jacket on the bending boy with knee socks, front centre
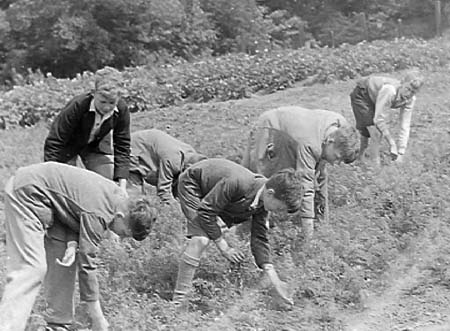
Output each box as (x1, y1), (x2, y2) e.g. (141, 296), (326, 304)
(178, 159), (271, 267)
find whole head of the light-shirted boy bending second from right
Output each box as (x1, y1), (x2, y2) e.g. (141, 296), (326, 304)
(322, 125), (360, 164)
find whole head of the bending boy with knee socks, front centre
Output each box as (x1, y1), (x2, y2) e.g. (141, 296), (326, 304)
(262, 168), (303, 213)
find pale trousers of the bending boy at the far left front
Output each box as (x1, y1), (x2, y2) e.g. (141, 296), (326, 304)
(0, 179), (47, 331)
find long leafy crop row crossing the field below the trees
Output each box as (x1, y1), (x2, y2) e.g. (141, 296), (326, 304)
(0, 38), (450, 126)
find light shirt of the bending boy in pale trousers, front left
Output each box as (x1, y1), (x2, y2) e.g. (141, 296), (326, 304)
(9, 162), (128, 301)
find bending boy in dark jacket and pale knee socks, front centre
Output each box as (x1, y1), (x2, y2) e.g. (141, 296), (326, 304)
(173, 159), (302, 310)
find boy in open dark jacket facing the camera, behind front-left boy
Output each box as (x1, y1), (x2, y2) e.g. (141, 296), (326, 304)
(44, 67), (130, 185)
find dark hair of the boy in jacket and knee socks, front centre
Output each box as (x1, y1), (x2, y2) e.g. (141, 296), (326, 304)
(266, 168), (304, 213)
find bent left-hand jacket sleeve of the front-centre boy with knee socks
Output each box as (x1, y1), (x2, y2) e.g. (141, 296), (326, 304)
(197, 178), (238, 240)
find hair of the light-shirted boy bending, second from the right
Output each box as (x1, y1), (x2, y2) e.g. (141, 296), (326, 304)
(331, 125), (360, 163)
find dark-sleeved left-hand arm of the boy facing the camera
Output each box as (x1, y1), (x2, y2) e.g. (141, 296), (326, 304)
(44, 101), (83, 162)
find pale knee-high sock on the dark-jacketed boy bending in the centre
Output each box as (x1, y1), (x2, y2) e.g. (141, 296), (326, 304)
(172, 252), (200, 312)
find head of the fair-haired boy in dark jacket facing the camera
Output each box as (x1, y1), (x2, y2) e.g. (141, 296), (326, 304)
(94, 67), (122, 115)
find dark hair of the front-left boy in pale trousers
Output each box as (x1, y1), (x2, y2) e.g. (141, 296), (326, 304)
(129, 198), (157, 241)
